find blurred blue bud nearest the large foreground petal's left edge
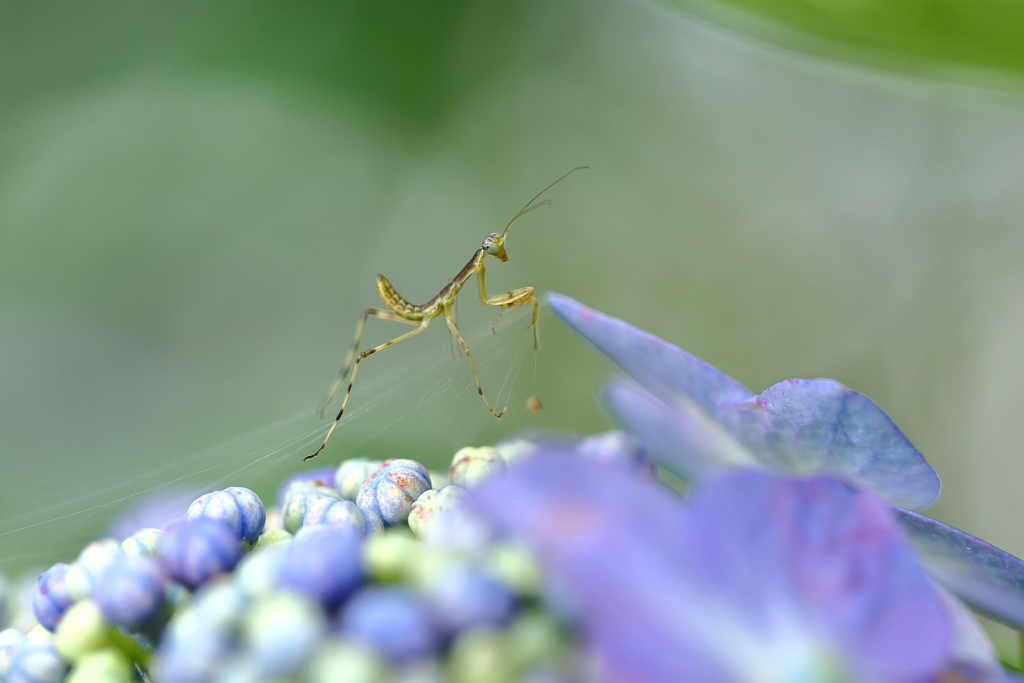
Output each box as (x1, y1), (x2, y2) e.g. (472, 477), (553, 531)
(426, 566), (516, 635)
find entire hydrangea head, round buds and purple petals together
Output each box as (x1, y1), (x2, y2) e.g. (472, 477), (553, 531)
(0, 295), (1024, 683)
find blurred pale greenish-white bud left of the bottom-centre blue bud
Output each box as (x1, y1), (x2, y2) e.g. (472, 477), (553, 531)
(242, 591), (327, 678)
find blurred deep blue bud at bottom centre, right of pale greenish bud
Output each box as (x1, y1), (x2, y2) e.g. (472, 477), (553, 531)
(338, 586), (438, 665)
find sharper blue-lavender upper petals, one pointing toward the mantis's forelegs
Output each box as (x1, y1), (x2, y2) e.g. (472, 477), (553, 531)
(548, 294), (939, 508)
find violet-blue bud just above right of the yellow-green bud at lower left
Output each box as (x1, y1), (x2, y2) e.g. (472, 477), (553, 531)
(92, 557), (167, 629)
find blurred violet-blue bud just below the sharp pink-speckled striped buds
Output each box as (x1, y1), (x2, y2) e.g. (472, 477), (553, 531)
(280, 525), (364, 611)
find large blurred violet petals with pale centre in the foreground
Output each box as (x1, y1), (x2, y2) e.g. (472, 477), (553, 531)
(472, 456), (951, 682)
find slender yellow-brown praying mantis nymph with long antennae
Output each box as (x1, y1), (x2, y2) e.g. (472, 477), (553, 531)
(302, 166), (590, 461)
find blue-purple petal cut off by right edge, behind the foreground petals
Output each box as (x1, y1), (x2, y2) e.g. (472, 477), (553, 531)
(893, 507), (1024, 631)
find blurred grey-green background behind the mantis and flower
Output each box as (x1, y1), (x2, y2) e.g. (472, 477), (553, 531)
(0, 0), (1024, 634)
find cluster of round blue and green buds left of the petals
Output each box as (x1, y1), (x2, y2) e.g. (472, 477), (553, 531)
(0, 447), (593, 683)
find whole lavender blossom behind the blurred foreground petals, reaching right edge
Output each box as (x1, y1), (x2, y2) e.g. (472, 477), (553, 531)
(547, 294), (1024, 630)
